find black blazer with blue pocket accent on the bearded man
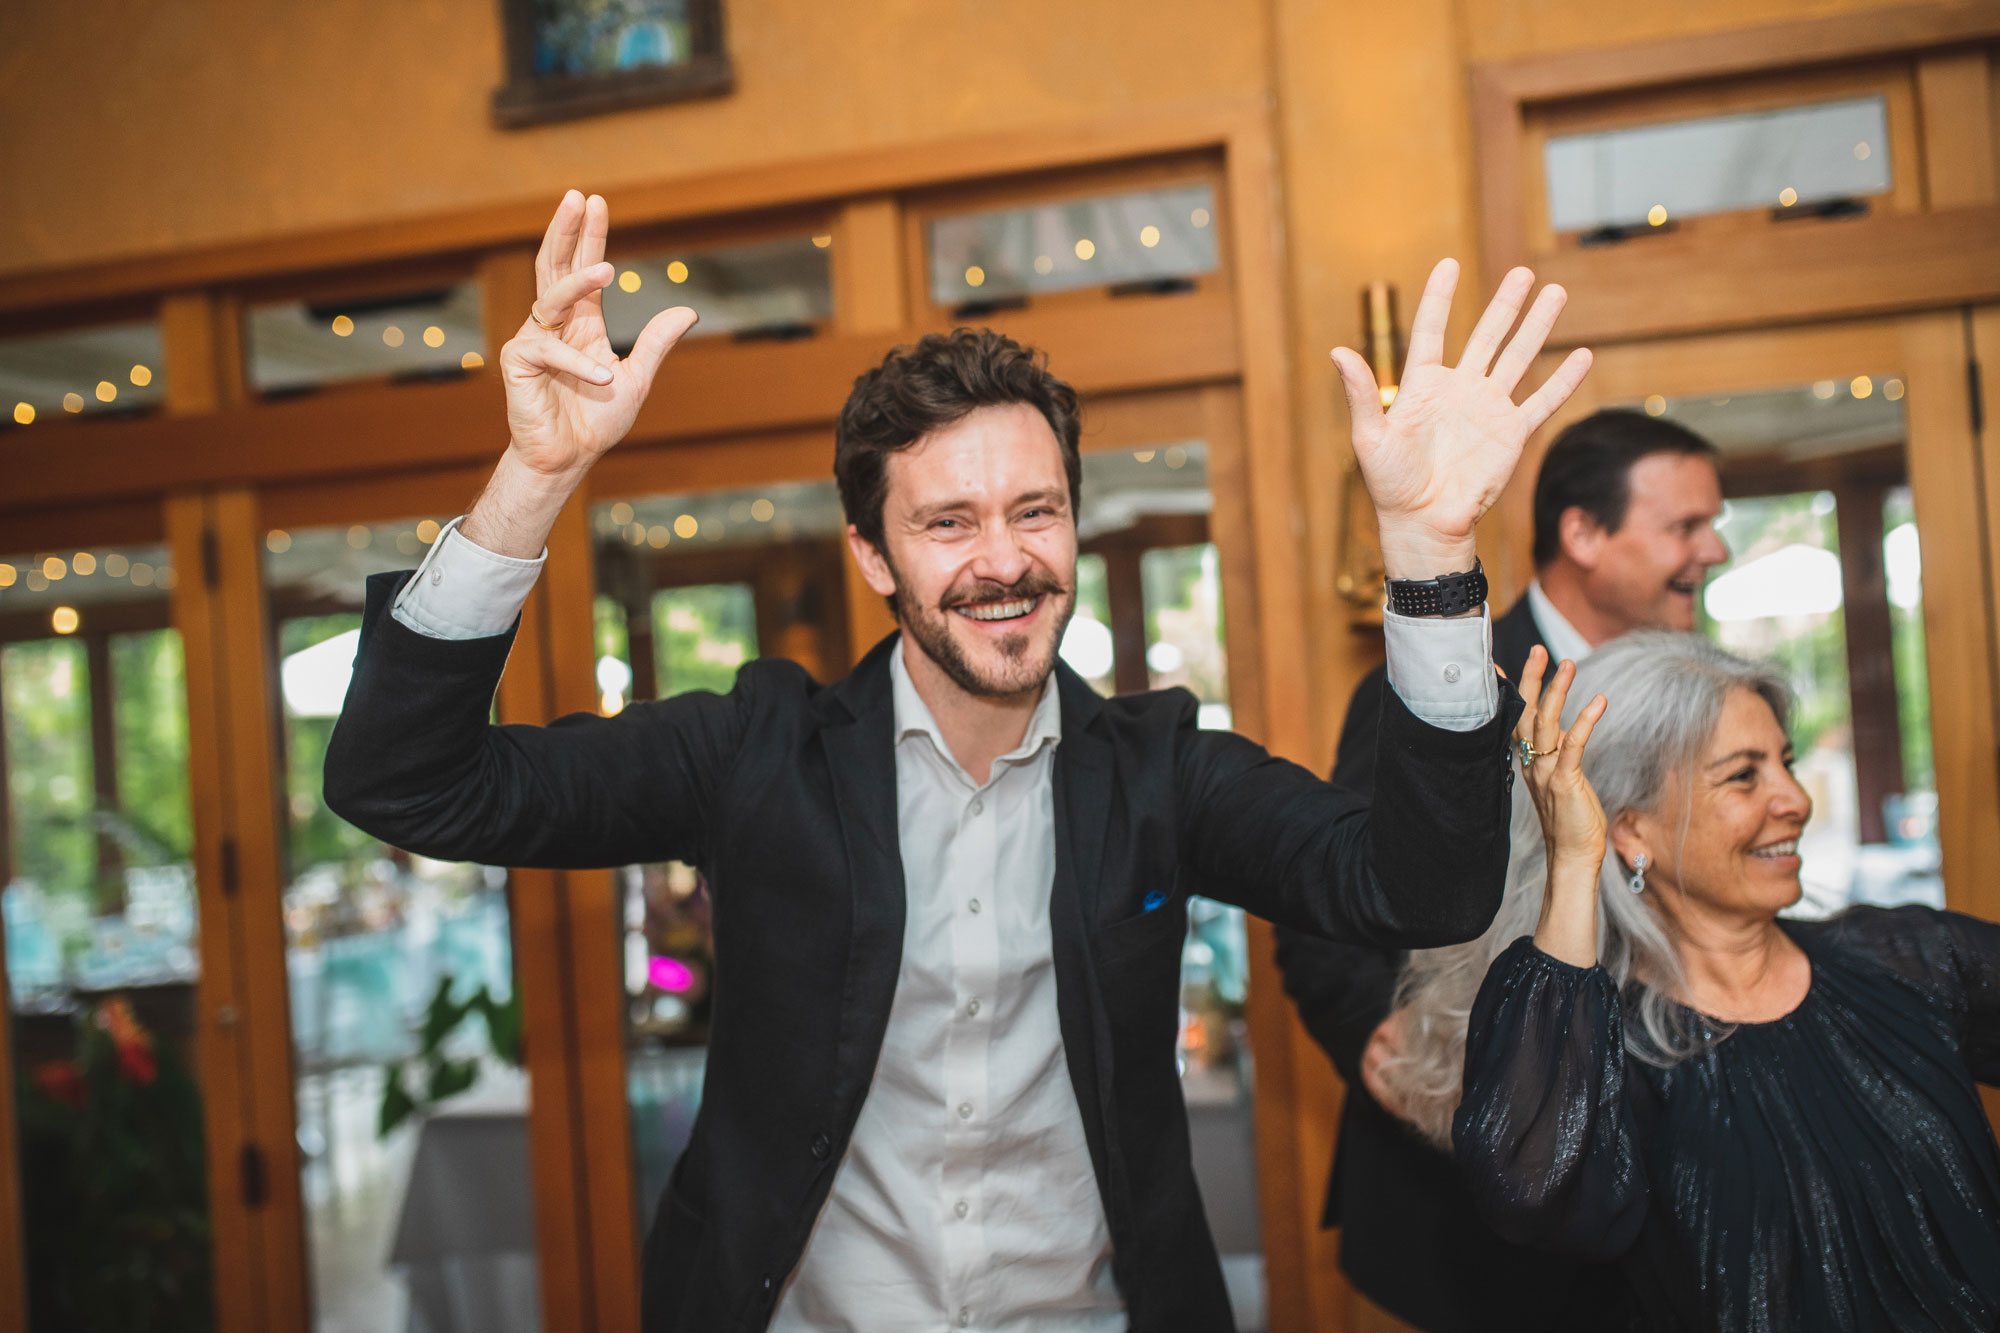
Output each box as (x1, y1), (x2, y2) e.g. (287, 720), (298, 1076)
(326, 574), (1518, 1333)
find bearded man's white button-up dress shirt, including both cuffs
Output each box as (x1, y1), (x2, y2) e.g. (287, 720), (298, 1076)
(392, 520), (1498, 1333)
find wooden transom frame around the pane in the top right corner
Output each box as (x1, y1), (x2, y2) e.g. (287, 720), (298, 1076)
(1470, 0), (2000, 346)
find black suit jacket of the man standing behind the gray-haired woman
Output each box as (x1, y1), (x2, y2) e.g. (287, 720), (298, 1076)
(1278, 596), (1618, 1333)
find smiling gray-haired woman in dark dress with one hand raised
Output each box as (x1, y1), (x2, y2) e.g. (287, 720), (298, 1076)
(1386, 632), (2000, 1333)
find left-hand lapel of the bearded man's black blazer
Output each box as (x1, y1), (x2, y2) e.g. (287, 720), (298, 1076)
(820, 634), (906, 1117)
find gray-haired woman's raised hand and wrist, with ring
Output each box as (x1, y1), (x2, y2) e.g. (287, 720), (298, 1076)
(1514, 646), (1608, 967)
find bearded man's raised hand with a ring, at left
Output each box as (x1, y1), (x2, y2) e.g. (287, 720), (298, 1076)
(500, 190), (696, 476)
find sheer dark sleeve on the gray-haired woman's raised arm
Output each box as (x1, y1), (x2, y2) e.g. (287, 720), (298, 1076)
(1452, 937), (1648, 1259)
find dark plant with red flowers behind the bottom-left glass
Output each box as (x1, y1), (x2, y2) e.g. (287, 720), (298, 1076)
(16, 1005), (214, 1333)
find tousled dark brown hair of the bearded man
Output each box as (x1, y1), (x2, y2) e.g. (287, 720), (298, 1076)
(834, 328), (1084, 552)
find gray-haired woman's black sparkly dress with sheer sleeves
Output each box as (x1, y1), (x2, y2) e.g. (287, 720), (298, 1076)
(1452, 907), (2000, 1333)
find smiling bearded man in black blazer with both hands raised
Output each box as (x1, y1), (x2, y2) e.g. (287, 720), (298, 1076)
(326, 192), (1590, 1333)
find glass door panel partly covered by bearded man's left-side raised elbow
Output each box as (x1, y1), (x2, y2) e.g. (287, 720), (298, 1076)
(264, 518), (540, 1333)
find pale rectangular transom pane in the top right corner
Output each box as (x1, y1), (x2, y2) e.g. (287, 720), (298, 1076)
(1544, 96), (1890, 232)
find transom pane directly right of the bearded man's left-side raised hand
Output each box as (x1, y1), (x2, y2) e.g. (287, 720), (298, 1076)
(604, 236), (834, 350)
